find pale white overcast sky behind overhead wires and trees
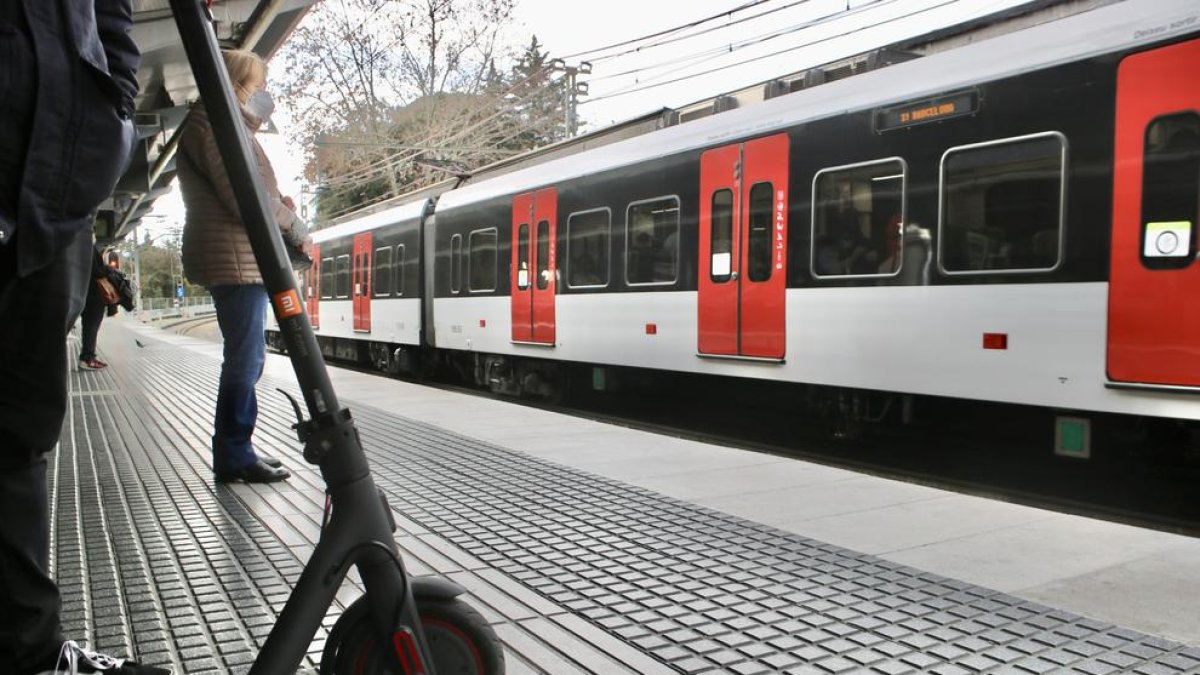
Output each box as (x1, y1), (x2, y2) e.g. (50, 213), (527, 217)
(143, 0), (1027, 232)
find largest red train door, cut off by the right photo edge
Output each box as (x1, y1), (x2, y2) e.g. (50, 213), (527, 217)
(1108, 40), (1200, 387)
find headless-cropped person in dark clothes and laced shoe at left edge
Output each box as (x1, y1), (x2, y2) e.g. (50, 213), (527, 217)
(0, 0), (169, 675)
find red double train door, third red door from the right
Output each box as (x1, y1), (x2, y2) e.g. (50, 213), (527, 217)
(511, 187), (558, 345)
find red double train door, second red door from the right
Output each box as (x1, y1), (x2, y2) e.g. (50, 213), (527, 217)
(697, 133), (788, 359)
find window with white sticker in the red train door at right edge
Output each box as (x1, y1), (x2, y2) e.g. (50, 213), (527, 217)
(1141, 112), (1200, 269)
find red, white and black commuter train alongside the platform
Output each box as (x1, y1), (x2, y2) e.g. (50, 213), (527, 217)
(269, 0), (1200, 453)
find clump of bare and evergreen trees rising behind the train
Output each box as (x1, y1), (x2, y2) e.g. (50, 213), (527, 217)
(271, 0), (585, 221)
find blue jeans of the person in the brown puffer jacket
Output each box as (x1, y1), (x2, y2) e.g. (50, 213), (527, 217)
(209, 285), (266, 472)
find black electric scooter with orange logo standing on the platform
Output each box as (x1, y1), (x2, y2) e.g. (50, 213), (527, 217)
(170, 0), (504, 675)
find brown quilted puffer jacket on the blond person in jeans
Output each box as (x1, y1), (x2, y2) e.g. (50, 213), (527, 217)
(176, 104), (307, 286)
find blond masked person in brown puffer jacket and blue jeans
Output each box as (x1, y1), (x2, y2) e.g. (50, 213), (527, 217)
(178, 49), (310, 483)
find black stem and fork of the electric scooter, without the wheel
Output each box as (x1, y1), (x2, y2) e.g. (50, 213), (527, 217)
(170, 0), (433, 675)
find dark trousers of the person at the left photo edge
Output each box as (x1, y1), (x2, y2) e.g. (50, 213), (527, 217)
(0, 224), (92, 673)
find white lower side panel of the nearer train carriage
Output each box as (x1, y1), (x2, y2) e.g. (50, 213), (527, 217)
(434, 283), (1200, 419)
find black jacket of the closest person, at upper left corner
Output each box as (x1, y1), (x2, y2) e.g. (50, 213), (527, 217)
(0, 0), (140, 276)
